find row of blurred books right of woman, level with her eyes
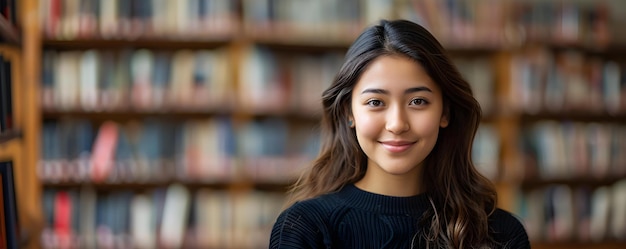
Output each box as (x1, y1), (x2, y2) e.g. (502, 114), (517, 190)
(509, 47), (626, 115)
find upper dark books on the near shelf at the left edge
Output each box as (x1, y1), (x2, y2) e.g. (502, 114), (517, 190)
(0, 54), (14, 133)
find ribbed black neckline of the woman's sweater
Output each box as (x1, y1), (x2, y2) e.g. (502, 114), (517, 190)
(338, 184), (430, 217)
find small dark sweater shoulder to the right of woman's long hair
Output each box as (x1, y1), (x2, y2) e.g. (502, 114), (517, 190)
(489, 208), (530, 248)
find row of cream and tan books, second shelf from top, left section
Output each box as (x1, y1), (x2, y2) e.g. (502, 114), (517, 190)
(41, 49), (235, 112)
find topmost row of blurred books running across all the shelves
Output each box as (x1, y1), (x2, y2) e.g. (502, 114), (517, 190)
(40, 0), (612, 47)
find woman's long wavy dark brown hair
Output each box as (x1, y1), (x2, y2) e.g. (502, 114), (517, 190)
(290, 20), (496, 248)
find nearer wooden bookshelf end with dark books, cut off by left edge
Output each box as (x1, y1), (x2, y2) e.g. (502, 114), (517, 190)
(0, 1), (43, 248)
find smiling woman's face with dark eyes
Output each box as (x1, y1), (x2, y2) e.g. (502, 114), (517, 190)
(350, 55), (448, 181)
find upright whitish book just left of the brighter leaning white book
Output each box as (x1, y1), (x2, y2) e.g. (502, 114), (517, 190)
(130, 194), (156, 249)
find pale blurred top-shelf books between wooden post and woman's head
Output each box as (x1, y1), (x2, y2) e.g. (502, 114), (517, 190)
(242, 0), (368, 44)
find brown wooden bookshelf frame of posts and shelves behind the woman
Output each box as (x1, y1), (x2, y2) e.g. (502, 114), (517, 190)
(17, 0), (626, 249)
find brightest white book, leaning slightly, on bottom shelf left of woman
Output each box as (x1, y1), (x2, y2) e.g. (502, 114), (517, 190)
(159, 183), (190, 248)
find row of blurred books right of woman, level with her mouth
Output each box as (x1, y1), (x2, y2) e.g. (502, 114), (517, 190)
(520, 121), (626, 179)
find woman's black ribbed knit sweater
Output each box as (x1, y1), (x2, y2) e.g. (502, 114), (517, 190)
(270, 184), (530, 249)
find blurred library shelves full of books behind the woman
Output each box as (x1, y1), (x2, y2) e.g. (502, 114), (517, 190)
(0, 0), (626, 249)
